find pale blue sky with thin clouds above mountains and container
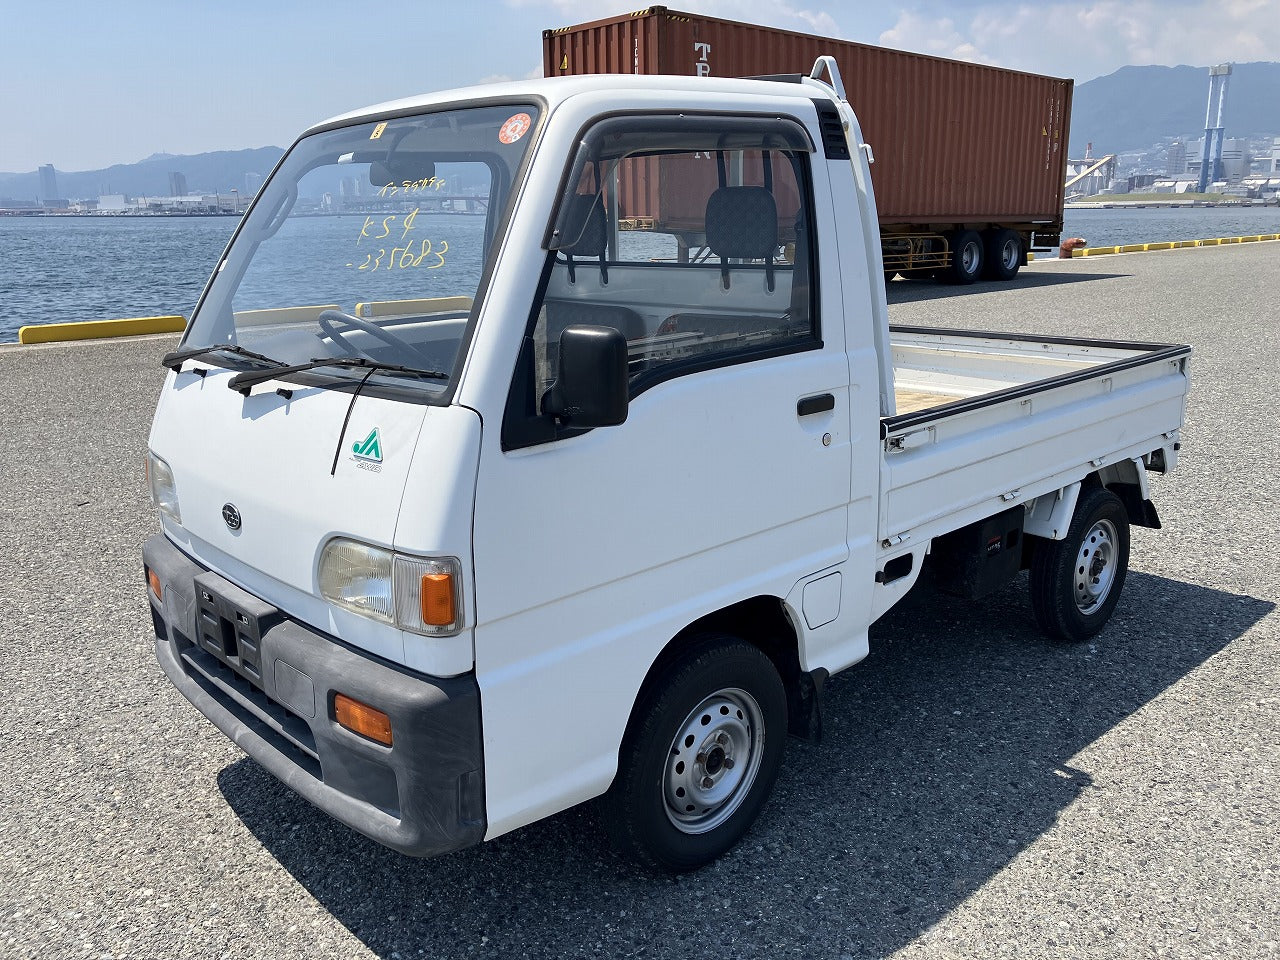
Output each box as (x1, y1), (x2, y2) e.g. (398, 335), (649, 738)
(0, 0), (1280, 173)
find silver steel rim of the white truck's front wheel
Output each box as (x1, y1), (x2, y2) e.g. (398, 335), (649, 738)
(662, 687), (764, 835)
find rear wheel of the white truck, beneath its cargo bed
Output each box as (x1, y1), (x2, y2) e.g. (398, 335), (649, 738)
(1030, 486), (1129, 643)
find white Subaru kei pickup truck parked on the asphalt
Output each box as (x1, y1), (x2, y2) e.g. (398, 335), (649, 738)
(143, 58), (1190, 870)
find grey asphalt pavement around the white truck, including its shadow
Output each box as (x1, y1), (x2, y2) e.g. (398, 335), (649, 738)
(0, 243), (1280, 960)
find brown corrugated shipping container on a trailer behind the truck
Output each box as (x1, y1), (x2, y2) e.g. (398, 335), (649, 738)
(543, 6), (1073, 239)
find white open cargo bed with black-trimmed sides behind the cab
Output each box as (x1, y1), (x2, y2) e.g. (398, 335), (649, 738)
(878, 326), (1192, 544)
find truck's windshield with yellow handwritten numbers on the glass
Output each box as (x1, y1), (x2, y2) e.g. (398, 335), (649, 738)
(183, 104), (538, 393)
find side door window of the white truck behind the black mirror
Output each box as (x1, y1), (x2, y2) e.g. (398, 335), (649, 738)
(504, 115), (820, 445)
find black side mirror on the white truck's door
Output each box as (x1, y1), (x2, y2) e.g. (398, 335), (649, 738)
(543, 324), (627, 428)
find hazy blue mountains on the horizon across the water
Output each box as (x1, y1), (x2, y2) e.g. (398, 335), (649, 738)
(0, 63), (1280, 200)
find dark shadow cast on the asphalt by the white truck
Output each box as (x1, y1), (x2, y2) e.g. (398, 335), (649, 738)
(219, 572), (1275, 960)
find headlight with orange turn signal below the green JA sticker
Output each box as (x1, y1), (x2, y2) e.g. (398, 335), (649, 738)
(320, 538), (462, 636)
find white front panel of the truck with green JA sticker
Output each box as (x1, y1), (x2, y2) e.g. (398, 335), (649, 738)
(151, 367), (432, 662)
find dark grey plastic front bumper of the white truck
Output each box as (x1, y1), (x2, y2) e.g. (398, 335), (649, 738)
(142, 534), (485, 856)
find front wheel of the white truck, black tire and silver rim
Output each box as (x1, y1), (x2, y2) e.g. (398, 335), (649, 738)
(603, 636), (787, 873)
